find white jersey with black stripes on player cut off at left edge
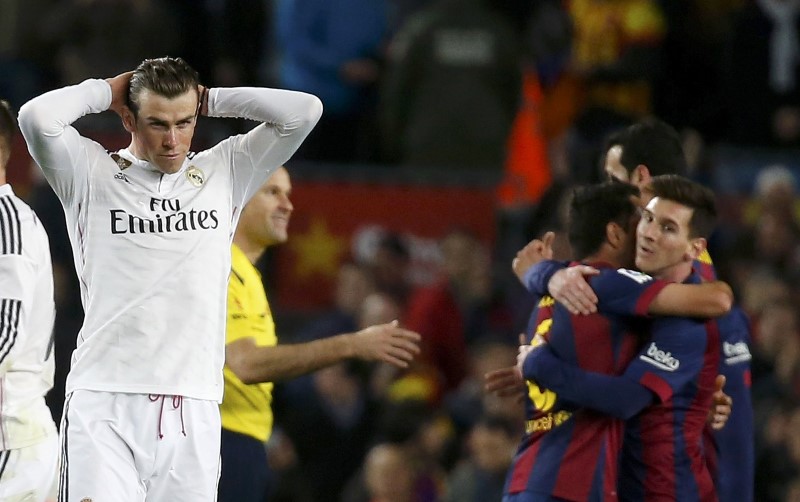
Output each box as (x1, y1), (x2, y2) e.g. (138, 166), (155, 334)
(0, 185), (56, 450)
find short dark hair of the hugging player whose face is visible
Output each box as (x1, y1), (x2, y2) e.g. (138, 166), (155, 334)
(646, 174), (717, 239)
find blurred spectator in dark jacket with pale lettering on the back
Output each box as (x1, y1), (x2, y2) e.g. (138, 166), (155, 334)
(379, 0), (521, 171)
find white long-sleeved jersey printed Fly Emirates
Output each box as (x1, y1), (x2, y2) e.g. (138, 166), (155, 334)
(19, 80), (322, 401)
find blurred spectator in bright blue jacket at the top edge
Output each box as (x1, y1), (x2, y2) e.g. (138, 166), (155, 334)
(275, 0), (387, 162)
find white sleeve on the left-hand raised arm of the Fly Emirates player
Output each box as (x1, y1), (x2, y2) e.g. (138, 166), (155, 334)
(19, 79), (111, 201)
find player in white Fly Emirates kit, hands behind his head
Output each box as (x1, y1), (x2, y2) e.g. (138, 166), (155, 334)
(19, 57), (322, 502)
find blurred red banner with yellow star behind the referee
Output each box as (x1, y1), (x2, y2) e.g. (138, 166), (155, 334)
(278, 179), (495, 310)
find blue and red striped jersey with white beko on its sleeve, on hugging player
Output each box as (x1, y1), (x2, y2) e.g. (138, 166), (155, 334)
(619, 273), (720, 501)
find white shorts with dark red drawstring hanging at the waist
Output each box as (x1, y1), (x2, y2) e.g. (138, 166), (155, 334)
(58, 390), (220, 502)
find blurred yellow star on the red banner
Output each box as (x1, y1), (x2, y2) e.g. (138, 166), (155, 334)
(289, 218), (347, 279)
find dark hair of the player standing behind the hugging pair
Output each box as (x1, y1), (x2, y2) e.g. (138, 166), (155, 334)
(606, 117), (689, 176)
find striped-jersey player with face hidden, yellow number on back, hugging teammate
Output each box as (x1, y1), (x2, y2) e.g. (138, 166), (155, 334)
(487, 183), (730, 501)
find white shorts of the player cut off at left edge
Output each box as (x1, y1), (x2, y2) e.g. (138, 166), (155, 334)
(0, 432), (58, 502)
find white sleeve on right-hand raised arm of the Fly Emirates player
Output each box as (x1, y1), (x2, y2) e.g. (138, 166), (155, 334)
(208, 87), (322, 200)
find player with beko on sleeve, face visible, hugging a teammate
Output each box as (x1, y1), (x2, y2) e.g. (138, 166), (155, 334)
(521, 176), (720, 500)
